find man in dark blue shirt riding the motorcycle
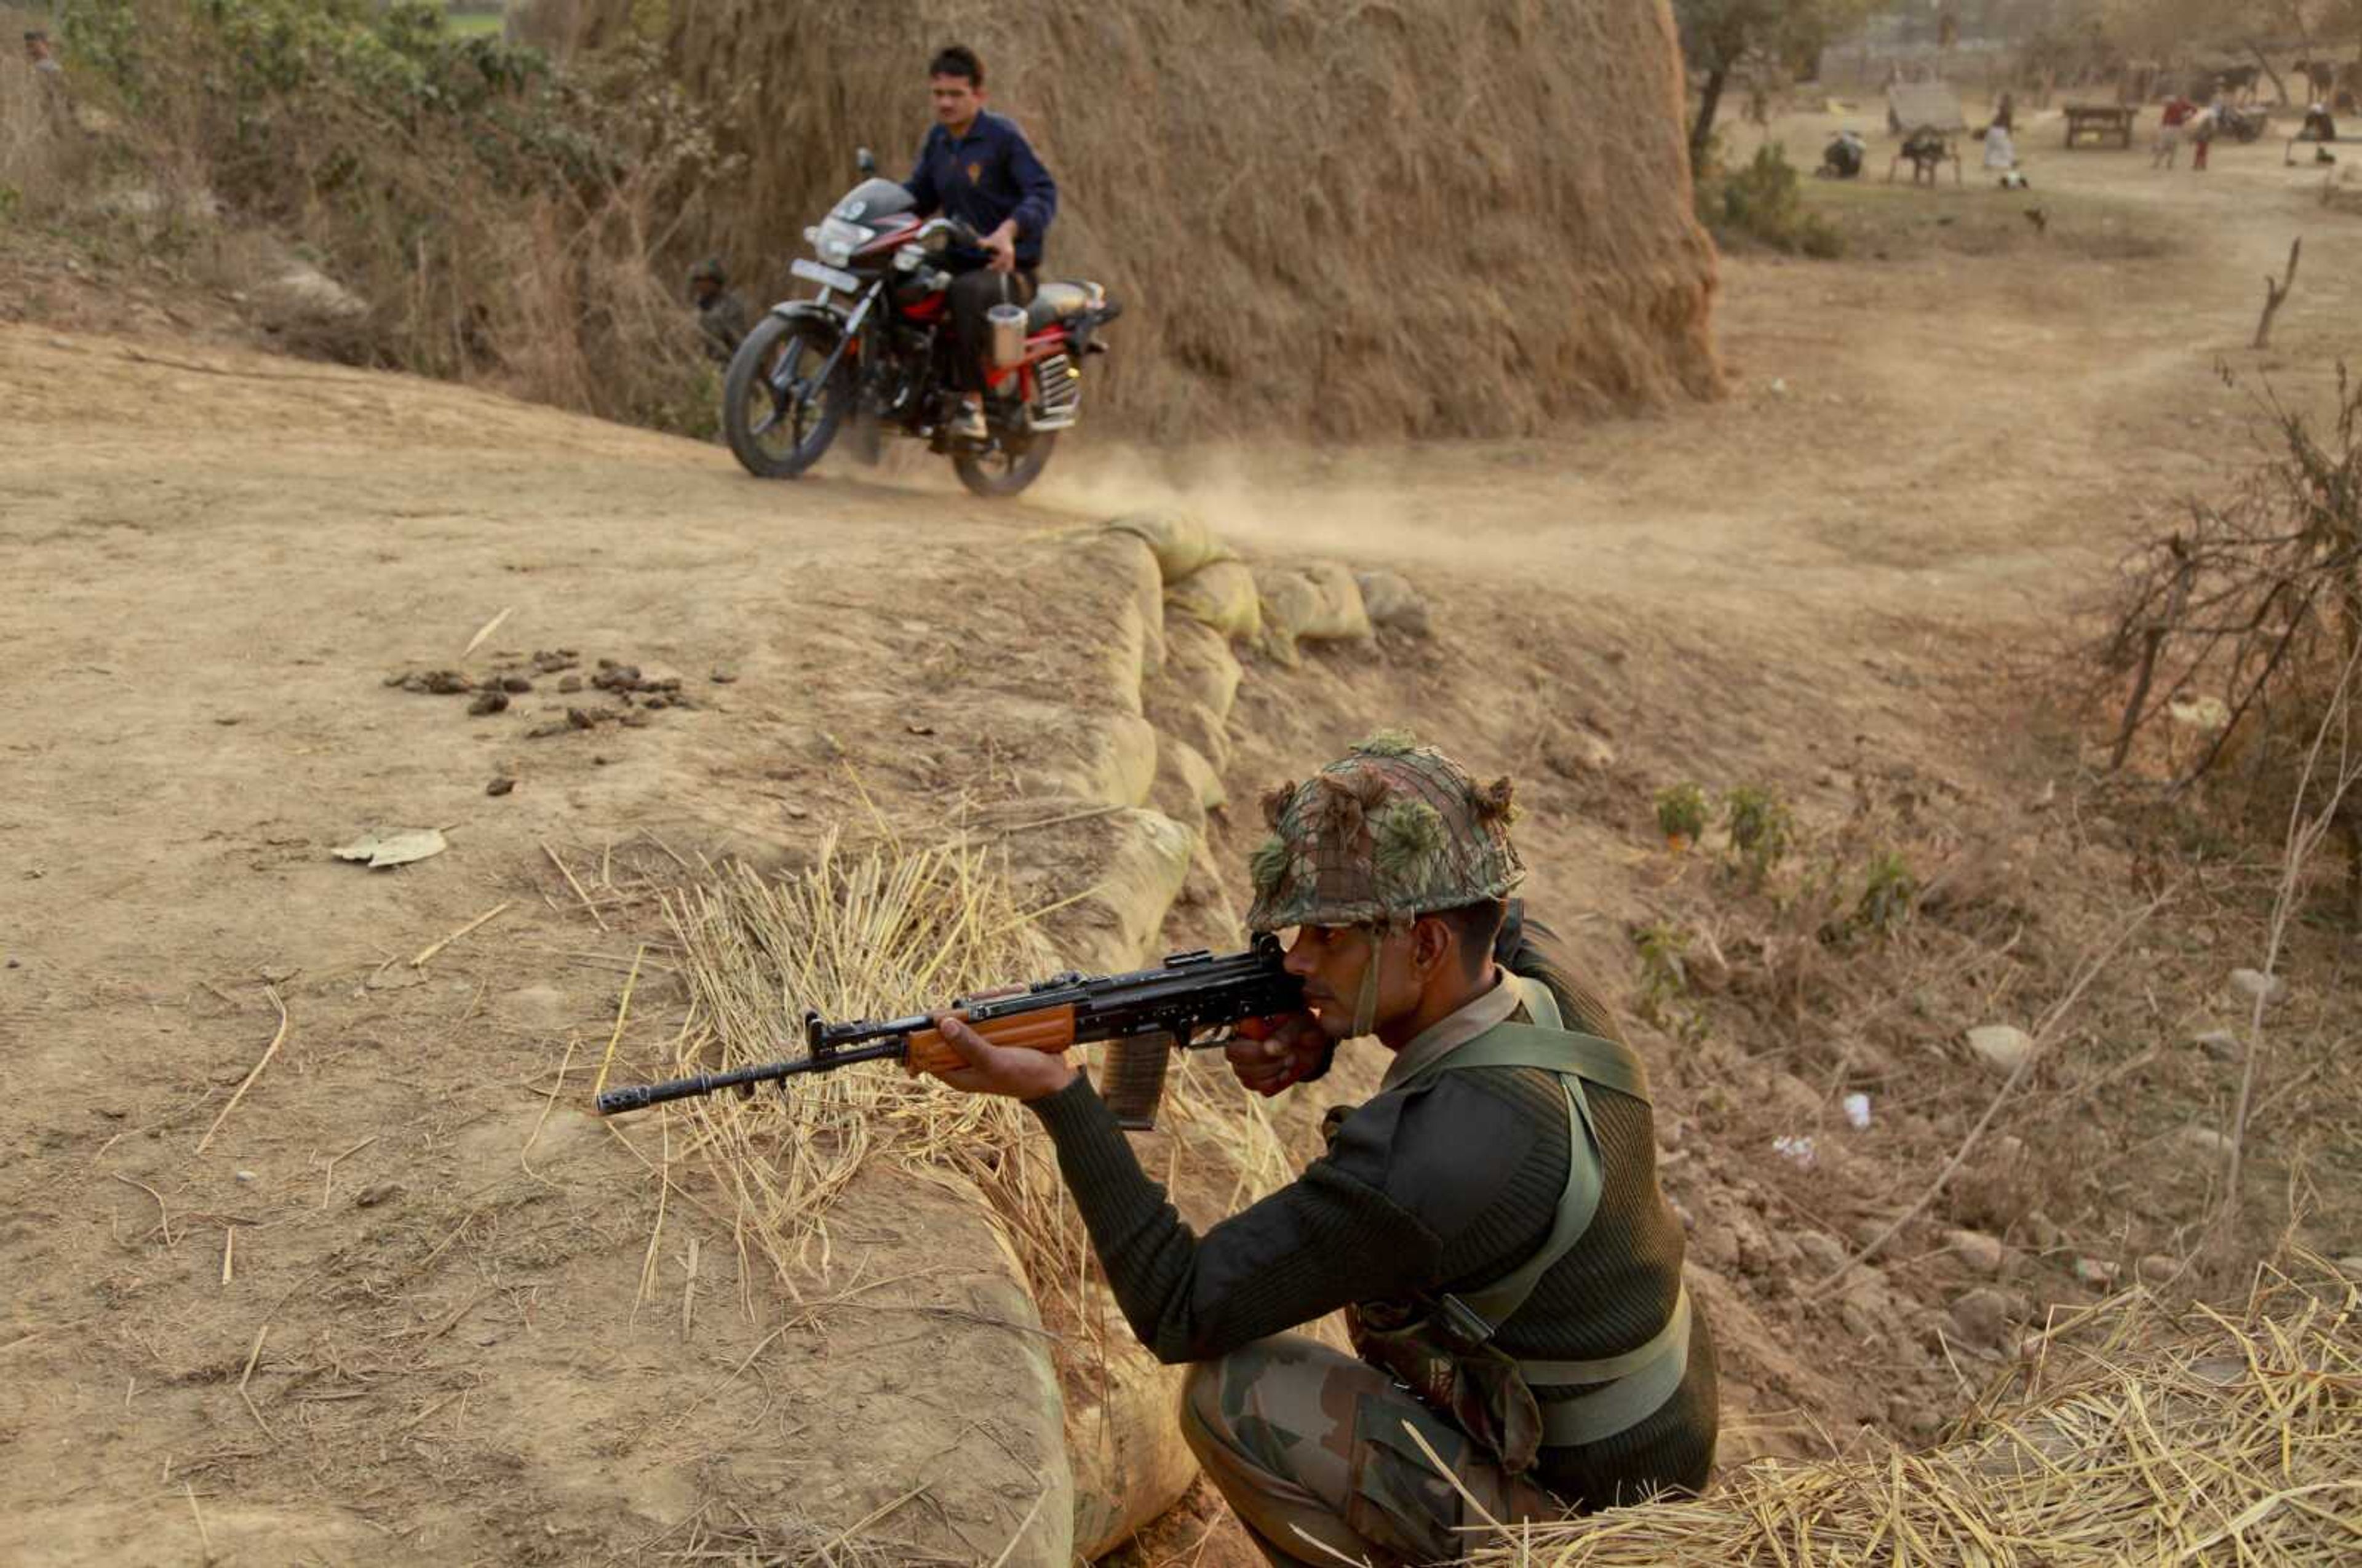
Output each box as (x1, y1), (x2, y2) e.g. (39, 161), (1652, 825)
(902, 42), (1058, 442)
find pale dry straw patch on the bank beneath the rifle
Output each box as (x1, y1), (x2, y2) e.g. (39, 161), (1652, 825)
(650, 836), (1292, 1356)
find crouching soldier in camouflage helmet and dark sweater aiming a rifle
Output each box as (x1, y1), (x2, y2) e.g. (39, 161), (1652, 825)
(921, 737), (1715, 1563)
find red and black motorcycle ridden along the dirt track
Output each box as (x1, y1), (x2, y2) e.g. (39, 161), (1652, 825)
(723, 149), (1122, 496)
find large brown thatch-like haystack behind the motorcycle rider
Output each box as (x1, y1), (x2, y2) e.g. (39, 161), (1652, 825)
(564, 0), (1720, 437)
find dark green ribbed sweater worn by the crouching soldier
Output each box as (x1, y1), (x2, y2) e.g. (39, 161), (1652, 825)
(1032, 921), (1715, 1506)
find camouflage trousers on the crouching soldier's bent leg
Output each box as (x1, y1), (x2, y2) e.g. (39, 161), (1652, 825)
(1181, 1334), (1566, 1568)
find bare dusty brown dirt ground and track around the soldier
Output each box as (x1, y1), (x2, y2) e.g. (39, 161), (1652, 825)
(0, 103), (2362, 1563)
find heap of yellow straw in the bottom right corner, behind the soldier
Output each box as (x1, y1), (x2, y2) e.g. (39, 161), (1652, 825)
(1469, 1259), (2362, 1568)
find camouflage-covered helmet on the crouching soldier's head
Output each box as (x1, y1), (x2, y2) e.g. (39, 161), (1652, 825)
(1247, 732), (1526, 931)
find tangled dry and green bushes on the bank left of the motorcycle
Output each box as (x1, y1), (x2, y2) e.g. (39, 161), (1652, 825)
(55, 0), (723, 432)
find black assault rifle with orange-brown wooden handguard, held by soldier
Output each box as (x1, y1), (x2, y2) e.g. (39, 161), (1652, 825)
(598, 935), (1304, 1131)
